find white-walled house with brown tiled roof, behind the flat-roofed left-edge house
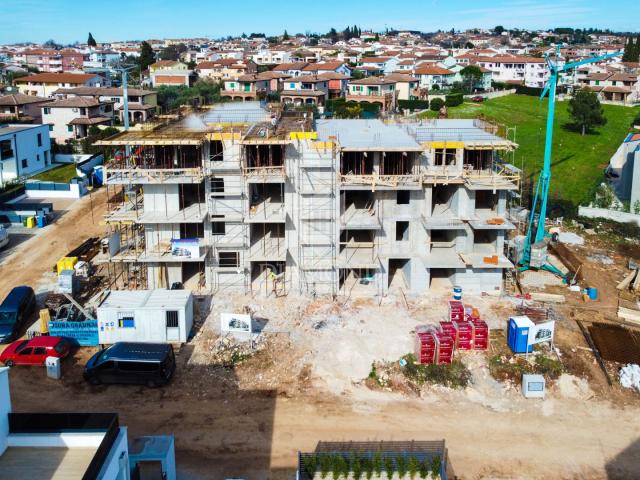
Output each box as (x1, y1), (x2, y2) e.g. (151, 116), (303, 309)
(42, 97), (114, 144)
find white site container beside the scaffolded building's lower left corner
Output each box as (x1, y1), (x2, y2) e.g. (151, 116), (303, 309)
(97, 289), (193, 345)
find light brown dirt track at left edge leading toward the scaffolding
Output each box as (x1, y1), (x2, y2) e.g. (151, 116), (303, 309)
(0, 188), (107, 298)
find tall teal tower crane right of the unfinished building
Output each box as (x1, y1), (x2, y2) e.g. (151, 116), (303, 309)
(518, 45), (624, 277)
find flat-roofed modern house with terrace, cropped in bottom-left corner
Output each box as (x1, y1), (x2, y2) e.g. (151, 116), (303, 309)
(0, 367), (176, 480)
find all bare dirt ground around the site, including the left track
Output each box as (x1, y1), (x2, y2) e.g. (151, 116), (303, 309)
(0, 201), (640, 480)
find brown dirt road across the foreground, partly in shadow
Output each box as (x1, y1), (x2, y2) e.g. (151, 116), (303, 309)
(10, 342), (640, 480)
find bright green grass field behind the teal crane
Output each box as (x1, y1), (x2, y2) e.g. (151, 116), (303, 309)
(418, 95), (640, 206)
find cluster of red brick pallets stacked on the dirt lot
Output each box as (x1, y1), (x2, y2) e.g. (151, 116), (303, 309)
(415, 300), (489, 364)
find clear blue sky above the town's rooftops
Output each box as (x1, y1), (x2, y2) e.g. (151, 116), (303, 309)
(0, 0), (640, 43)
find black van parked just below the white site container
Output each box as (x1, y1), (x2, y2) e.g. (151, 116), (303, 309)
(83, 342), (176, 387)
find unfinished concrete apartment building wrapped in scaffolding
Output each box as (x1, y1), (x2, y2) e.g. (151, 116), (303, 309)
(98, 102), (519, 295)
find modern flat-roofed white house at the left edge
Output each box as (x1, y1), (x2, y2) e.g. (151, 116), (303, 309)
(0, 124), (53, 186)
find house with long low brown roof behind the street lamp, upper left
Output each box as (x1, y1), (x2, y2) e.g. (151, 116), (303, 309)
(54, 87), (158, 123)
